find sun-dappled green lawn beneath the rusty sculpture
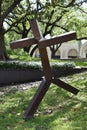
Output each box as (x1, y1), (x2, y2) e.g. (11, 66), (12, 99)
(0, 72), (87, 130)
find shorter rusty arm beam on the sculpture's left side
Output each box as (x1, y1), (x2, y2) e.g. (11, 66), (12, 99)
(10, 38), (37, 49)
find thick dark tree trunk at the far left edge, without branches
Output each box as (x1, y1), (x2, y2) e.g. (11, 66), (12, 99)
(0, 28), (8, 60)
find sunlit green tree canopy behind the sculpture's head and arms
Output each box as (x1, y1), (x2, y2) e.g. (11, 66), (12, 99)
(0, 0), (87, 60)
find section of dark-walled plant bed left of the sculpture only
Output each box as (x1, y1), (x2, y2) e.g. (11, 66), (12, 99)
(0, 61), (42, 86)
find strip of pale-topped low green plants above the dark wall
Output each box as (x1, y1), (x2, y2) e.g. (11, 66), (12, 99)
(0, 61), (75, 70)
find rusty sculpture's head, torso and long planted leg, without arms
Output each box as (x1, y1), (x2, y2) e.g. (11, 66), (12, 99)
(23, 20), (52, 119)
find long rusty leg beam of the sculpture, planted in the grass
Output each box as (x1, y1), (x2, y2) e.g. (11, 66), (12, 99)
(23, 79), (51, 119)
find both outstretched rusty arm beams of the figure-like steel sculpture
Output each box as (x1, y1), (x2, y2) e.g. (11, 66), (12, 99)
(10, 31), (76, 49)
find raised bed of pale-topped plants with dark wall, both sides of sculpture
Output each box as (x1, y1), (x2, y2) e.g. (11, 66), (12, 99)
(0, 61), (87, 86)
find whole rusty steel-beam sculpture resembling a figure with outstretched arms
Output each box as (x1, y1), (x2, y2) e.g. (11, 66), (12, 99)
(10, 19), (79, 119)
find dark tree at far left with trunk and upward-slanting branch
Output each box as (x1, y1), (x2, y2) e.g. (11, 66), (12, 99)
(0, 0), (21, 60)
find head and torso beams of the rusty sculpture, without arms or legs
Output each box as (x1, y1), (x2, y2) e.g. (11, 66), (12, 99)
(30, 20), (52, 80)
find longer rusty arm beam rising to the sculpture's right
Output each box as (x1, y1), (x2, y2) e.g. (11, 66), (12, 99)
(38, 31), (76, 48)
